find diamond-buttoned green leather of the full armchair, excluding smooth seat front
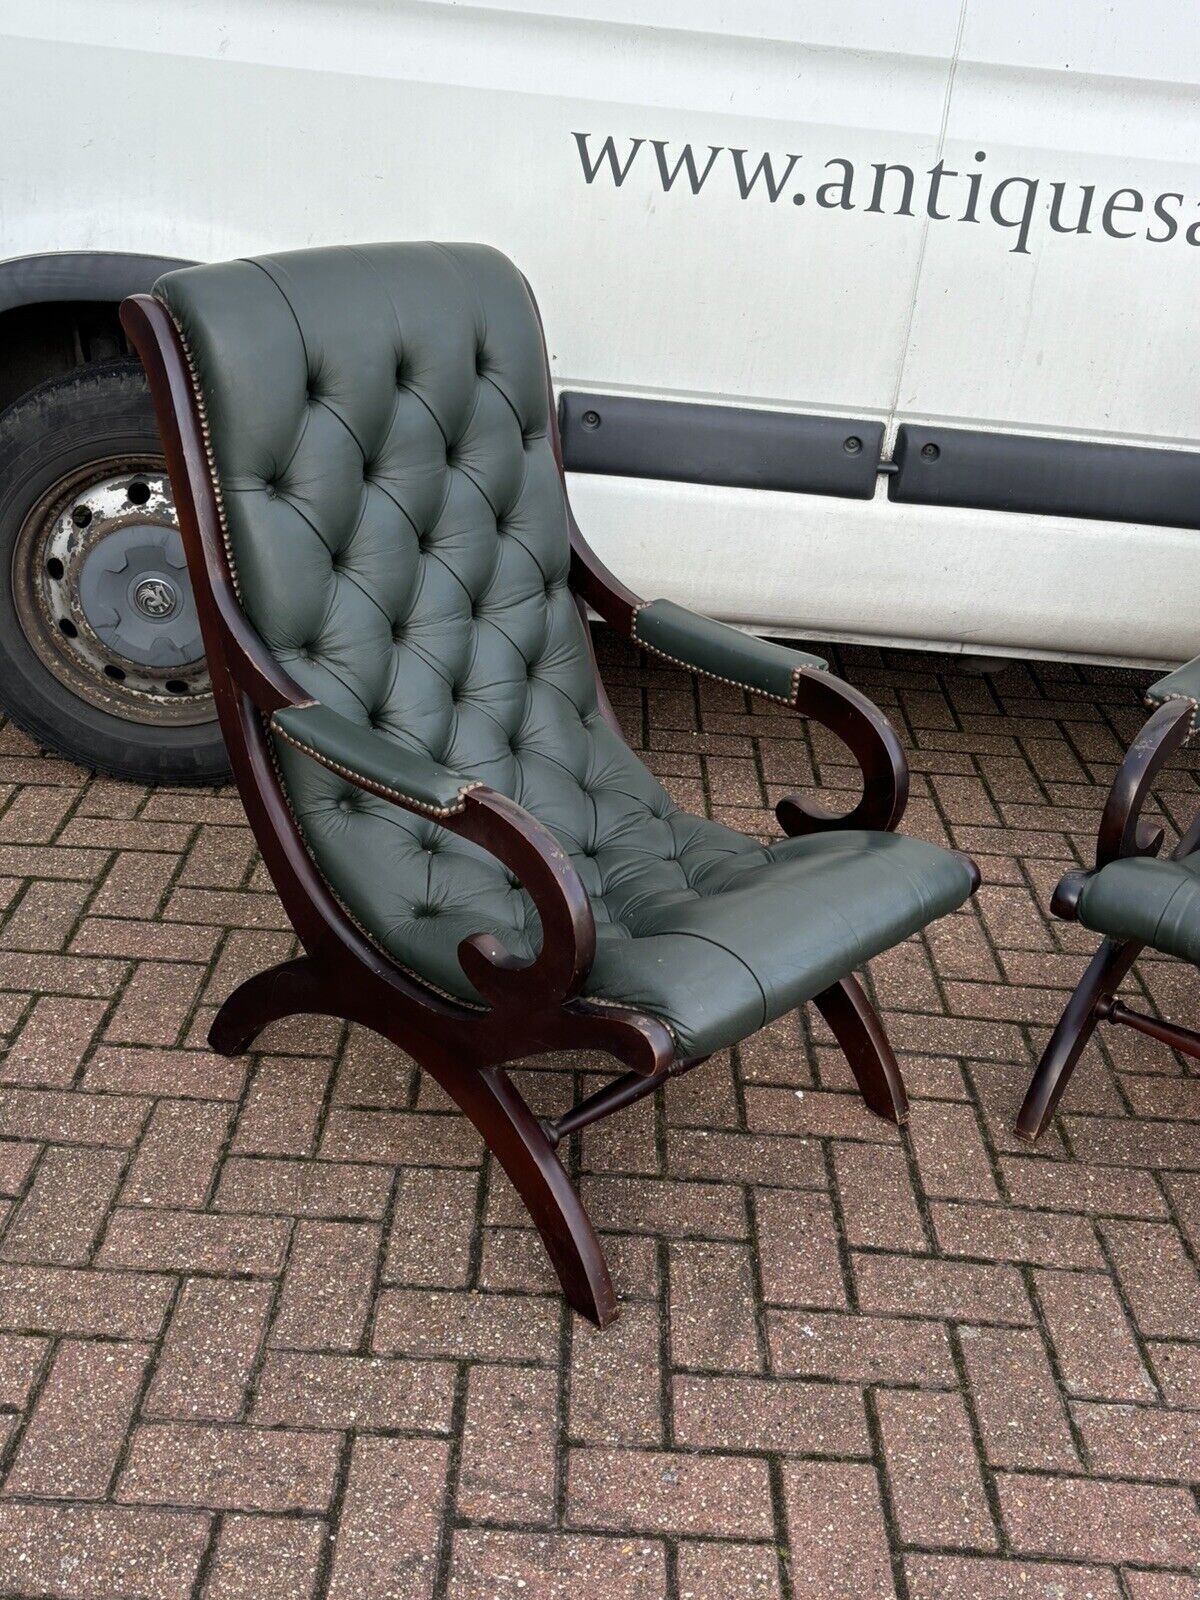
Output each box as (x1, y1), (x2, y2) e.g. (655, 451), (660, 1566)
(155, 243), (752, 998)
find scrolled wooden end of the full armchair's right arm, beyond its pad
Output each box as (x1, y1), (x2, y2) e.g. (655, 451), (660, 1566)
(774, 670), (909, 834)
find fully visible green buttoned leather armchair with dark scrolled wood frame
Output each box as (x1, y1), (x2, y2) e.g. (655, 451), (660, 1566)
(123, 243), (978, 1323)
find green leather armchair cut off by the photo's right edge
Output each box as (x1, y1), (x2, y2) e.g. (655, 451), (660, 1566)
(1016, 656), (1200, 1141)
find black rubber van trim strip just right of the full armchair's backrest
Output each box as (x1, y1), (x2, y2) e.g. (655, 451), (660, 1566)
(558, 390), (883, 499)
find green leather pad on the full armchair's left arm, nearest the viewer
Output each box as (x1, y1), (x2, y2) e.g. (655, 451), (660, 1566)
(270, 701), (483, 818)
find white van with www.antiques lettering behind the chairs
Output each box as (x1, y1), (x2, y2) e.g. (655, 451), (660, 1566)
(0, 0), (1200, 779)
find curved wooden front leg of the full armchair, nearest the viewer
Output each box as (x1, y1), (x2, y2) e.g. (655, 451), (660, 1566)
(421, 1056), (618, 1328)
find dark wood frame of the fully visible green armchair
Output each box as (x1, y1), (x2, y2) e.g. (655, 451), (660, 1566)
(122, 294), (966, 1326)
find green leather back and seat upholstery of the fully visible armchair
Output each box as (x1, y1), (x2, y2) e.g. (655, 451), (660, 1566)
(155, 243), (973, 1056)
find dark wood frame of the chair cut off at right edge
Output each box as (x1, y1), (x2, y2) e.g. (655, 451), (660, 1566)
(1016, 699), (1200, 1142)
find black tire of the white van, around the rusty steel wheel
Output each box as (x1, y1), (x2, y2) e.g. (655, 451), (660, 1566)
(0, 360), (229, 784)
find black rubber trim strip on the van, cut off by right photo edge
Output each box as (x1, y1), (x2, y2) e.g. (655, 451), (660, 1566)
(888, 422), (1200, 528)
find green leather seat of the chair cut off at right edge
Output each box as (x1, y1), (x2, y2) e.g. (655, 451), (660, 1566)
(1078, 853), (1200, 966)
